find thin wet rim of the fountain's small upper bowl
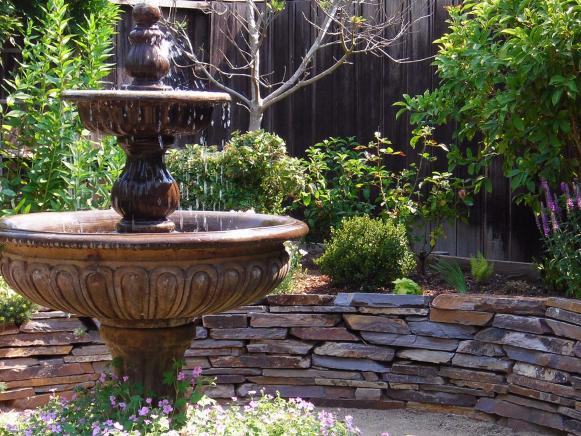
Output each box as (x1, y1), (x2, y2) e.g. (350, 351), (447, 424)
(62, 89), (232, 104)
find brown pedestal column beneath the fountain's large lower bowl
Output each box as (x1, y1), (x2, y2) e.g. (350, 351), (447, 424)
(100, 323), (196, 398)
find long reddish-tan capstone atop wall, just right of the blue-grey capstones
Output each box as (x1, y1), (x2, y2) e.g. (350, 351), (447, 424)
(432, 294), (546, 316)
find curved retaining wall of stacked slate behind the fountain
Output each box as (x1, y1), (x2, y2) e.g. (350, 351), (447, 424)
(0, 293), (581, 435)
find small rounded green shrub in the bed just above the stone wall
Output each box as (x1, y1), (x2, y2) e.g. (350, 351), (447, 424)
(317, 217), (415, 289)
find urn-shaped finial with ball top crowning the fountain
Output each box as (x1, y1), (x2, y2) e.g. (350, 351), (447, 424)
(125, 3), (170, 90)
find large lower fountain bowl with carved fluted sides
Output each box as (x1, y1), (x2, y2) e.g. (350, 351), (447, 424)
(0, 210), (308, 328)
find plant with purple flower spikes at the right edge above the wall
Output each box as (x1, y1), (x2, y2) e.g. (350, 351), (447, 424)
(537, 182), (581, 298)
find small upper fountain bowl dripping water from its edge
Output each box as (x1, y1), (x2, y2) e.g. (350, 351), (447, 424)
(62, 90), (231, 137)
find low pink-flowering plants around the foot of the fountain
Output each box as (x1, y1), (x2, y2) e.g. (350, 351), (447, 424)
(0, 368), (360, 436)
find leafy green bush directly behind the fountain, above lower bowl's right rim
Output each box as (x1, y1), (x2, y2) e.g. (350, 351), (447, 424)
(167, 130), (303, 213)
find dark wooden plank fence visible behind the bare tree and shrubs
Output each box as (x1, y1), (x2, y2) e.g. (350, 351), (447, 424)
(94, 0), (539, 261)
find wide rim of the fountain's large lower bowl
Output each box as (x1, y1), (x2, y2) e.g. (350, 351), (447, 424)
(0, 209), (308, 249)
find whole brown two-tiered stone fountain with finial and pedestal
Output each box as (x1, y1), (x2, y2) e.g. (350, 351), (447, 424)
(0, 4), (308, 396)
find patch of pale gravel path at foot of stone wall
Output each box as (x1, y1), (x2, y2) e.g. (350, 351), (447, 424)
(325, 408), (542, 436)
